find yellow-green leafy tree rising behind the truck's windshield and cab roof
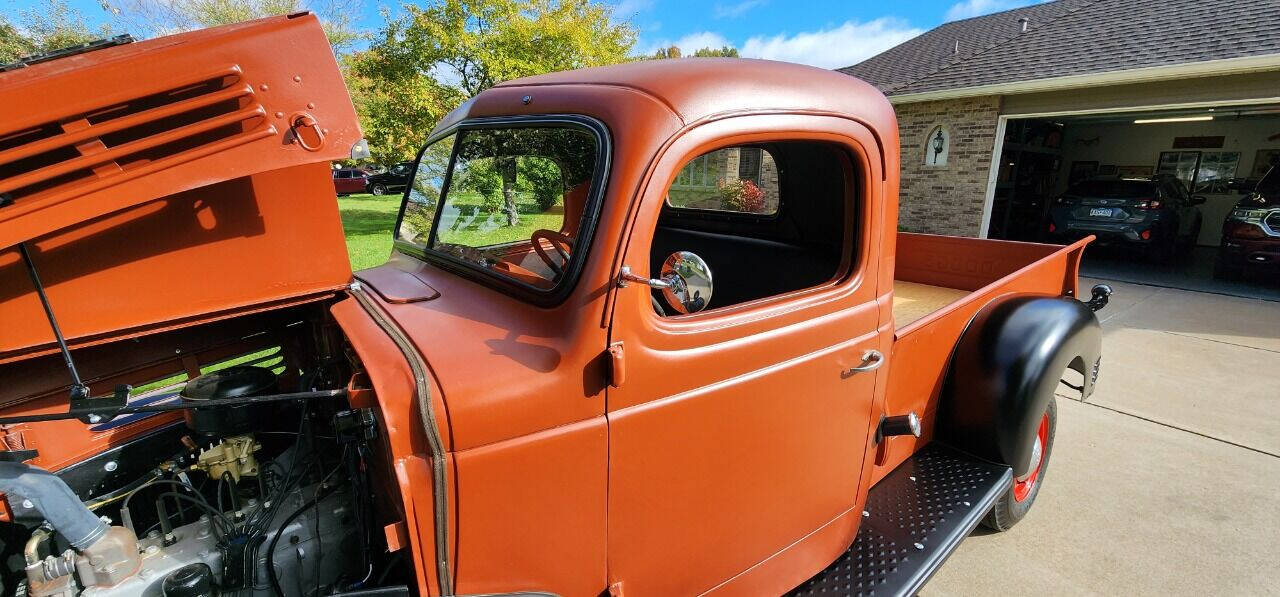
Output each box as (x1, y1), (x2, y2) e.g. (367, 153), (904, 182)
(348, 0), (635, 225)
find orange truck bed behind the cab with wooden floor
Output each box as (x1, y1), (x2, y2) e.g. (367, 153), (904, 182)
(873, 233), (1092, 482)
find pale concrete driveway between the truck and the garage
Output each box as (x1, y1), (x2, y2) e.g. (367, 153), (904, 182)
(922, 281), (1280, 596)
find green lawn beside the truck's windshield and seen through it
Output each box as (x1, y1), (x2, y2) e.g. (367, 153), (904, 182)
(338, 195), (564, 269)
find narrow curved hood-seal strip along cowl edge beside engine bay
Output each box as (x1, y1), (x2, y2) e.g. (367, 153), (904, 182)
(348, 281), (453, 596)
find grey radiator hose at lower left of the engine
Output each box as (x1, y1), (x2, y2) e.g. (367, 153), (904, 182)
(0, 462), (109, 551)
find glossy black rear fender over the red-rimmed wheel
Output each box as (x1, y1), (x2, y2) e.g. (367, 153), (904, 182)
(937, 296), (1102, 477)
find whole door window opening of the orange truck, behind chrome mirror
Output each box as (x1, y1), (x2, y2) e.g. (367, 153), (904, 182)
(649, 141), (858, 315)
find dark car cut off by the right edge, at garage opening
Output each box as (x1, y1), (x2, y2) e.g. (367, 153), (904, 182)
(1213, 168), (1280, 279)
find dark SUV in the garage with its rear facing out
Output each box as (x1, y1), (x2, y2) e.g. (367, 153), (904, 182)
(1048, 174), (1204, 261)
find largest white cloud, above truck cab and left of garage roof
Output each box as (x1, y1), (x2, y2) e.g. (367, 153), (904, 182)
(737, 17), (924, 68)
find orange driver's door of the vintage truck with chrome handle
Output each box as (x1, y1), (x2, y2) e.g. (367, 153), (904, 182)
(608, 117), (886, 596)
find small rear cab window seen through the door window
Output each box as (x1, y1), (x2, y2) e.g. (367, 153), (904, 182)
(667, 147), (778, 215)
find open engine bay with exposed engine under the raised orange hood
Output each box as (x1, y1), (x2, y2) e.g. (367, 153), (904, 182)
(0, 300), (412, 597)
